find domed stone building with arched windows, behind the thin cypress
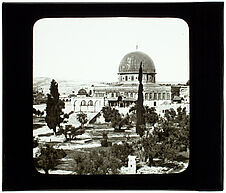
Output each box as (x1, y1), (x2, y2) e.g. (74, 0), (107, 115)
(93, 51), (171, 107)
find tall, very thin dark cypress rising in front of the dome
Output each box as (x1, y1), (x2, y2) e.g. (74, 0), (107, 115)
(136, 62), (145, 137)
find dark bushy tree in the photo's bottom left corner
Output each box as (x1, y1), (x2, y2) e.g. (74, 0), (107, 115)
(35, 144), (66, 174)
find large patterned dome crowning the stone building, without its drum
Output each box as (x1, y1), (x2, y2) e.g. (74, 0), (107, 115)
(119, 51), (155, 74)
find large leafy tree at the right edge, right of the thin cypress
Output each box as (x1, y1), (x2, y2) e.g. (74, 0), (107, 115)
(140, 107), (190, 166)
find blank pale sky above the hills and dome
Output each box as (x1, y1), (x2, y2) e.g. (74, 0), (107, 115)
(33, 18), (189, 82)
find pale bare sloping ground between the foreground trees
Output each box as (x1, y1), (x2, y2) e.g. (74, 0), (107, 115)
(33, 113), (189, 174)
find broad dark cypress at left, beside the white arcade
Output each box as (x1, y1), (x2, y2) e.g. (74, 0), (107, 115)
(45, 80), (65, 134)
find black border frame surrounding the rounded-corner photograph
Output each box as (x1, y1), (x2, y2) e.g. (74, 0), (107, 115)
(2, 2), (224, 190)
